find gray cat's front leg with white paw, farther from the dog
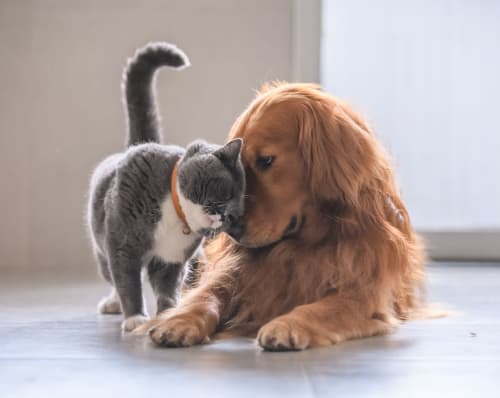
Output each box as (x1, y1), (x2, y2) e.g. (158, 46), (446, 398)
(110, 253), (148, 332)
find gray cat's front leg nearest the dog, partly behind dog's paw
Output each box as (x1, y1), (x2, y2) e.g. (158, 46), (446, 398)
(148, 257), (184, 314)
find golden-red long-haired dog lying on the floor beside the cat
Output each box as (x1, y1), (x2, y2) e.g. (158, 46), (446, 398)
(142, 82), (425, 351)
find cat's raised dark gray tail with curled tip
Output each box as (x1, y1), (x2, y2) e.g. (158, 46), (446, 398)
(122, 42), (189, 146)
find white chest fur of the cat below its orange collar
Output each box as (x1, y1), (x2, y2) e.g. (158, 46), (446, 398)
(153, 195), (199, 263)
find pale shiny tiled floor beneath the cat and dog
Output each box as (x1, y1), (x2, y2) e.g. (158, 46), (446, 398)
(0, 263), (500, 398)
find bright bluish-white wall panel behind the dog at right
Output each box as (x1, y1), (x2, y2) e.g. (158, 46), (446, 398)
(321, 0), (500, 231)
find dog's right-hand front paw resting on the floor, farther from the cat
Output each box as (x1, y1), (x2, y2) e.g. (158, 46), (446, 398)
(257, 316), (311, 351)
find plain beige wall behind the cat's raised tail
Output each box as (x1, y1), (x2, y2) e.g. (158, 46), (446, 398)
(0, 0), (293, 272)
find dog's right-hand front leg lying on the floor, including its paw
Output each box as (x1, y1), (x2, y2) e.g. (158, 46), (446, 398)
(257, 294), (395, 351)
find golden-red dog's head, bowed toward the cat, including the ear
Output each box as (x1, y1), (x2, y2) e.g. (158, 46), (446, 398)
(230, 84), (378, 247)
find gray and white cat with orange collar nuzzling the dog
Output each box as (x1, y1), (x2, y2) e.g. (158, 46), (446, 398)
(88, 43), (245, 331)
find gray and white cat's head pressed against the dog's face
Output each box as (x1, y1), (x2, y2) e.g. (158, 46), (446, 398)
(177, 139), (245, 235)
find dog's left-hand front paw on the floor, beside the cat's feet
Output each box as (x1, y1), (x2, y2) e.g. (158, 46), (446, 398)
(148, 314), (210, 347)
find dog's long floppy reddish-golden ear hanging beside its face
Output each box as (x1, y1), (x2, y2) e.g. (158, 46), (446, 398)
(299, 96), (377, 204)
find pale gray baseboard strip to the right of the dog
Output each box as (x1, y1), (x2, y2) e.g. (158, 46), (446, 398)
(420, 230), (500, 261)
